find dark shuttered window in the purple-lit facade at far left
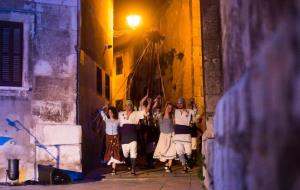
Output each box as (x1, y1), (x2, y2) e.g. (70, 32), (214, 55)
(0, 21), (23, 87)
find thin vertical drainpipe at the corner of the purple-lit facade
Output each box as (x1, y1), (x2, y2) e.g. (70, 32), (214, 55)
(76, 0), (81, 125)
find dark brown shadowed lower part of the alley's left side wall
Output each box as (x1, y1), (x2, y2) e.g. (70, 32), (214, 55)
(79, 51), (109, 173)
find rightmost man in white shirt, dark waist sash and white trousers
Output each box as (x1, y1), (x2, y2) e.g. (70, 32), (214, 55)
(174, 98), (195, 173)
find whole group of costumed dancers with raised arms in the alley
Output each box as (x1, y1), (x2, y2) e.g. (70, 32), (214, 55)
(98, 95), (200, 175)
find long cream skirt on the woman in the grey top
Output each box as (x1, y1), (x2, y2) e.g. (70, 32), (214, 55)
(153, 133), (176, 162)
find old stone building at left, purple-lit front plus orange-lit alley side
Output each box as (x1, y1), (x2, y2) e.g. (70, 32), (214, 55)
(0, 0), (113, 182)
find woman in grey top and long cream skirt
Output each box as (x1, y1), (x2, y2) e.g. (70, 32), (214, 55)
(153, 103), (176, 172)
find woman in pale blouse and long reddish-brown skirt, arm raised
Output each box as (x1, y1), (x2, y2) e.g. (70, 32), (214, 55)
(100, 107), (123, 175)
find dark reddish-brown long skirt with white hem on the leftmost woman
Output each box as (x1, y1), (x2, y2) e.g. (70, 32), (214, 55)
(104, 135), (123, 165)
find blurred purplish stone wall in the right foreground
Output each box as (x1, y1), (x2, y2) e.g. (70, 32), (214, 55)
(211, 0), (300, 190)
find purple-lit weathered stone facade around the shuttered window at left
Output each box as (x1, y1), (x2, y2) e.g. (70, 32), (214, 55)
(0, 0), (81, 181)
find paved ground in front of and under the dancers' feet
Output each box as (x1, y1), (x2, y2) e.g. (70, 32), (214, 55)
(0, 166), (201, 190)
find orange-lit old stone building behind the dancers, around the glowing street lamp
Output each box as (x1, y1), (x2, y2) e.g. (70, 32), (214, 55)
(112, 0), (204, 114)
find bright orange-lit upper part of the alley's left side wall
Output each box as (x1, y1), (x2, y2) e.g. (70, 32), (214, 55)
(81, 0), (113, 73)
